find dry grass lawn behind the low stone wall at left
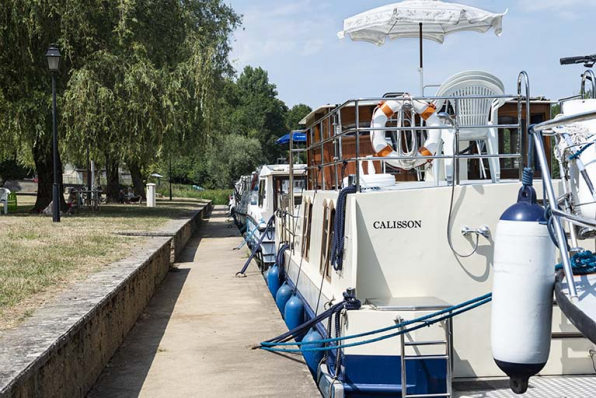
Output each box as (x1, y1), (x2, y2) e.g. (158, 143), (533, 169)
(0, 196), (208, 330)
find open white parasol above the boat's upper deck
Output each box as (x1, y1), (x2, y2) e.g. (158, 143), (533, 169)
(338, 0), (507, 94)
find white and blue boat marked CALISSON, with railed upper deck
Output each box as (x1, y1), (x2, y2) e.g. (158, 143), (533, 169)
(254, 72), (594, 398)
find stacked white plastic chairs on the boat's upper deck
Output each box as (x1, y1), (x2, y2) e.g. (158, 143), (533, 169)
(434, 71), (506, 182)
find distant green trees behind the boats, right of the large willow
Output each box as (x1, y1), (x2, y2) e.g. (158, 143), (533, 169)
(161, 66), (311, 188)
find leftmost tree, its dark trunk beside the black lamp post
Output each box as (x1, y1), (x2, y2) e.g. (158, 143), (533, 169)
(0, 0), (103, 210)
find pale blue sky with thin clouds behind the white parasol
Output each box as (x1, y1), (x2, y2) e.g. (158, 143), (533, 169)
(227, 0), (596, 108)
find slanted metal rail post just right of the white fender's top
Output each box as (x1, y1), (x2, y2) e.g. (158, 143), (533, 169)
(528, 127), (577, 300)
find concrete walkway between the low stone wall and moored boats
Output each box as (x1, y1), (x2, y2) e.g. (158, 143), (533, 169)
(89, 206), (320, 398)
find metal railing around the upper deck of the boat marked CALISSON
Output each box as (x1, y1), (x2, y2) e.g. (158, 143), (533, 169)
(290, 71), (530, 191)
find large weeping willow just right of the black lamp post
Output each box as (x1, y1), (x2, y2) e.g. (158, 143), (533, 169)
(60, 0), (239, 200)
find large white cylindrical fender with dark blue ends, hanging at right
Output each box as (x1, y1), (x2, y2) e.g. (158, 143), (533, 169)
(491, 186), (555, 394)
